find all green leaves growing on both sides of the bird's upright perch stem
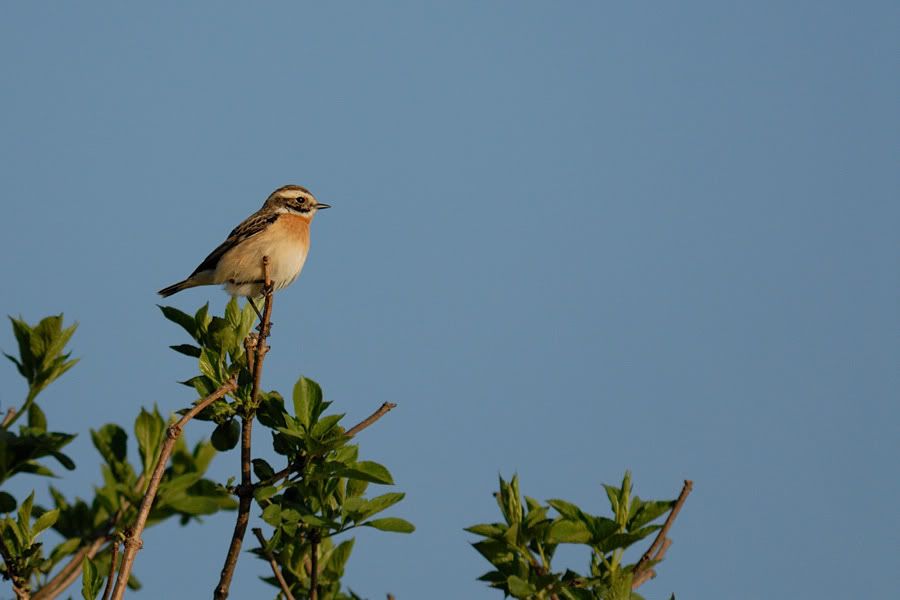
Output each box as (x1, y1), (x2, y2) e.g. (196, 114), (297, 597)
(160, 299), (414, 600)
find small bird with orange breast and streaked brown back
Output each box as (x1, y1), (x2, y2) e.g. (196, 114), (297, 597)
(159, 185), (330, 302)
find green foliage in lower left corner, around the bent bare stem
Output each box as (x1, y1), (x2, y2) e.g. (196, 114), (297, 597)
(0, 315), (237, 597)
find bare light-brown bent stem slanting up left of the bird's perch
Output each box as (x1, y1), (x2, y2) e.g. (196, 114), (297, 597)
(113, 377), (237, 600)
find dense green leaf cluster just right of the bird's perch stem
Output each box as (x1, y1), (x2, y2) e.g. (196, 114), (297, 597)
(253, 378), (415, 600)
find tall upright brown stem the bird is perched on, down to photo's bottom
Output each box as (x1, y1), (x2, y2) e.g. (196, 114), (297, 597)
(213, 256), (275, 600)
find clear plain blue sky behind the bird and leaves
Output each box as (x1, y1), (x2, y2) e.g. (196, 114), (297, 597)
(0, 1), (900, 600)
